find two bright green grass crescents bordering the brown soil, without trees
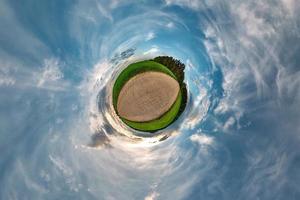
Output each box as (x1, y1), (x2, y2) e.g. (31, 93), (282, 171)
(113, 60), (182, 132)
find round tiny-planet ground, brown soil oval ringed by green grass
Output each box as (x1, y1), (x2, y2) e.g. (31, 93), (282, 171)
(112, 57), (186, 132)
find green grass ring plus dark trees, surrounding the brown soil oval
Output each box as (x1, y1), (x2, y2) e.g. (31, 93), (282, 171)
(113, 56), (187, 132)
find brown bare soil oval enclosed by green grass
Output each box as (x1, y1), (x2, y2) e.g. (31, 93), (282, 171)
(117, 72), (180, 122)
